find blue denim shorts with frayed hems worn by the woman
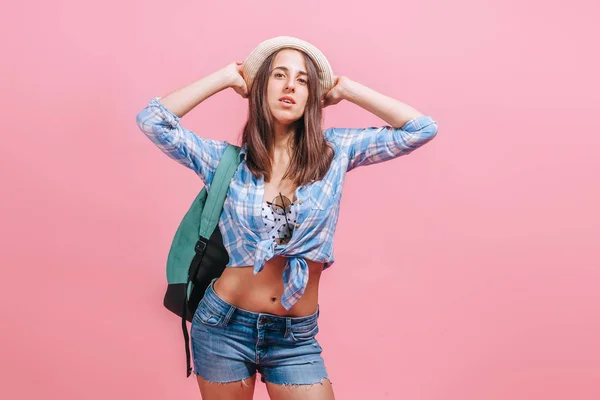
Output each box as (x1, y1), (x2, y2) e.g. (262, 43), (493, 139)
(190, 279), (329, 385)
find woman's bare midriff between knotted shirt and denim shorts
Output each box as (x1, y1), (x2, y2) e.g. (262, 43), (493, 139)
(214, 256), (324, 317)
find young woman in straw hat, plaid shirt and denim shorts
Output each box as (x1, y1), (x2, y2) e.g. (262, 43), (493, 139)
(137, 37), (437, 400)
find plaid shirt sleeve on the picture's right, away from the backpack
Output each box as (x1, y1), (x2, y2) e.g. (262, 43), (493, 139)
(327, 116), (438, 171)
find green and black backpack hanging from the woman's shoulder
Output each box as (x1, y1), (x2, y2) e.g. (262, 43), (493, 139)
(163, 144), (240, 377)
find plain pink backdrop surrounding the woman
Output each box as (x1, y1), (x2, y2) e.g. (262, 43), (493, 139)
(0, 0), (600, 400)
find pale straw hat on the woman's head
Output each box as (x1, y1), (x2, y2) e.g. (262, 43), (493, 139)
(242, 36), (334, 96)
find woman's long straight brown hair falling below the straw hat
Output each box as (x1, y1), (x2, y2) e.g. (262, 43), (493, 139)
(242, 49), (334, 186)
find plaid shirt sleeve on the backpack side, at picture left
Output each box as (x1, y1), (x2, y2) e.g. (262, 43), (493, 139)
(136, 97), (227, 186)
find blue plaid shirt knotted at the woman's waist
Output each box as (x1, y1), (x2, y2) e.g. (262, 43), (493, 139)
(136, 97), (437, 310)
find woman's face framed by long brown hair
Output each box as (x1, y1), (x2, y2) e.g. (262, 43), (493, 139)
(267, 49), (308, 126)
